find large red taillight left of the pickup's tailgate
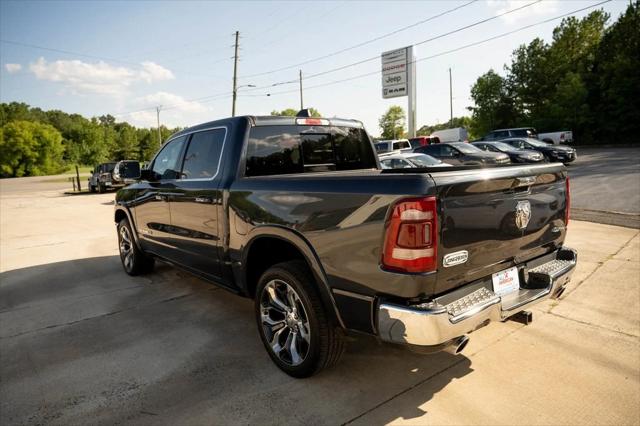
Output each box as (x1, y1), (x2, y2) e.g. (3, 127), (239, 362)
(382, 197), (438, 272)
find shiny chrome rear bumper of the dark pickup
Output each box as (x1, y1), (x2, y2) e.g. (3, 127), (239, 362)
(377, 248), (578, 347)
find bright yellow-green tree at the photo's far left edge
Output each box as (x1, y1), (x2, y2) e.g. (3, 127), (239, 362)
(0, 120), (64, 177)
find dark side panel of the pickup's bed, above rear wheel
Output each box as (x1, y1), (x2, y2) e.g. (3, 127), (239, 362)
(228, 170), (442, 298)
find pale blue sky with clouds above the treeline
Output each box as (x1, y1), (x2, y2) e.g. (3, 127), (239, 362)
(0, 0), (628, 135)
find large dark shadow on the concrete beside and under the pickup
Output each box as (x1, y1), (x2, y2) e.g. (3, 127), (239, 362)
(0, 256), (472, 424)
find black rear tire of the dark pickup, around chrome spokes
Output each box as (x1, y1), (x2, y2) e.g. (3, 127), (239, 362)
(254, 261), (345, 378)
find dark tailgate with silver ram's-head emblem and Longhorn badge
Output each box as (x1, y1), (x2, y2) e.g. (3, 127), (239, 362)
(431, 164), (566, 294)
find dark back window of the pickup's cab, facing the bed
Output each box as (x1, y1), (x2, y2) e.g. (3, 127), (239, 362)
(245, 126), (377, 176)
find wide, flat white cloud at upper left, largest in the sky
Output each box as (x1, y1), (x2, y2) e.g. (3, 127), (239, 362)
(29, 57), (175, 96)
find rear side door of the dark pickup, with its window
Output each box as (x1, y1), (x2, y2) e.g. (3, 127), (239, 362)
(169, 127), (227, 277)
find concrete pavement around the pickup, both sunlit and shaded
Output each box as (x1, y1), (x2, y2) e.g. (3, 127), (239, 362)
(0, 151), (640, 425)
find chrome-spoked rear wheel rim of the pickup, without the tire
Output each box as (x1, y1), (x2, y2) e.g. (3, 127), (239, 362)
(260, 280), (311, 366)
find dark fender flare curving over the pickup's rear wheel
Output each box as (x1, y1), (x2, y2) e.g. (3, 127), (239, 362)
(240, 225), (346, 329)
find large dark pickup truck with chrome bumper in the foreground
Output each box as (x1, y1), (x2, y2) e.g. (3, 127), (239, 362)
(114, 112), (576, 377)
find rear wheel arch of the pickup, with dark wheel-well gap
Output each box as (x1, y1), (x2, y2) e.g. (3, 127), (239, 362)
(240, 225), (344, 328)
